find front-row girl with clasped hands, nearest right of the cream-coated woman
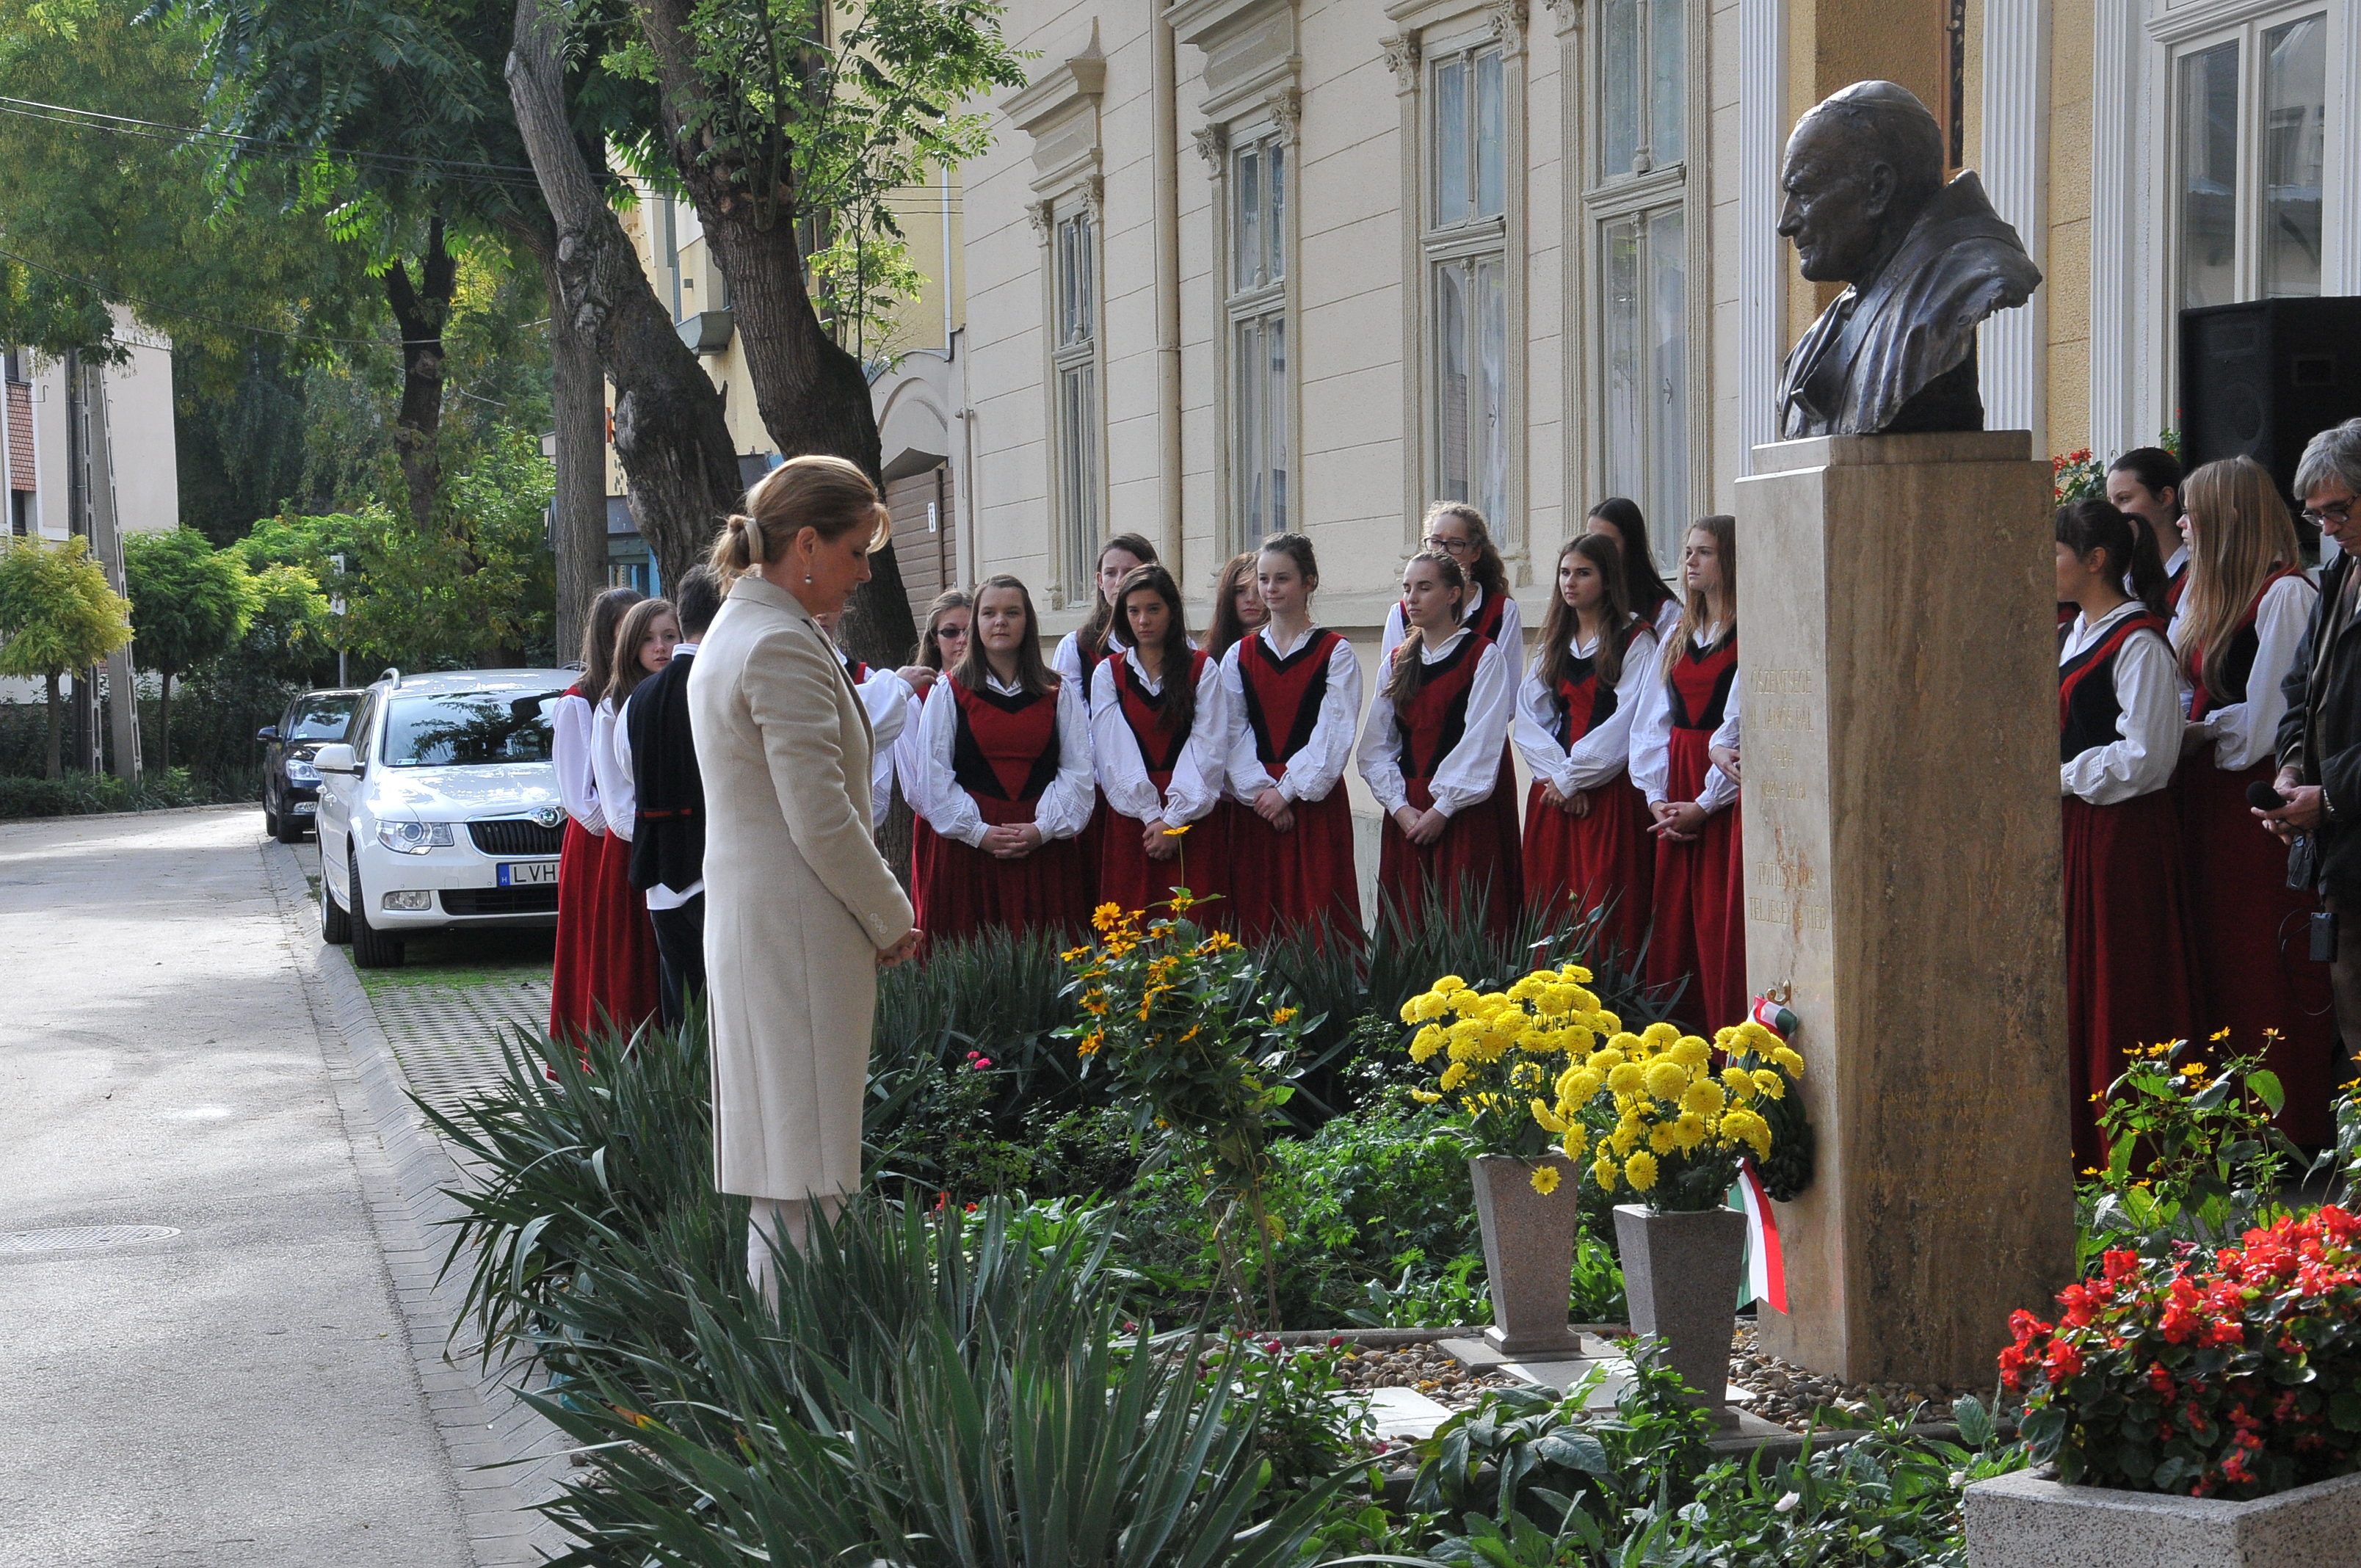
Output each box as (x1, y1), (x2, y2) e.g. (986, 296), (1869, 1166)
(918, 576), (1095, 943)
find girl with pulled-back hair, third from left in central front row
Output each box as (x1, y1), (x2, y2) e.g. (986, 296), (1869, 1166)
(1221, 534), (1360, 945)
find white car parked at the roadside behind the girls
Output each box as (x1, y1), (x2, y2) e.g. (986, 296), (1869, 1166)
(312, 671), (573, 968)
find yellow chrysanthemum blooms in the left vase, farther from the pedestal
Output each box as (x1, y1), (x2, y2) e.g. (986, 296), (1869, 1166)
(1402, 963), (1622, 1171)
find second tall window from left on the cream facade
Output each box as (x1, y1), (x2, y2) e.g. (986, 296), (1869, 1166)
(1227, 132), (1294, 548)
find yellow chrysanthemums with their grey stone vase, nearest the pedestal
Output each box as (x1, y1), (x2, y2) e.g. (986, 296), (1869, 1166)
(1532, 1023), (1804, 1422)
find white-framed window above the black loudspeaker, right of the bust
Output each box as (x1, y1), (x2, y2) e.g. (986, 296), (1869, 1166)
(2172, 7), (2328, 307)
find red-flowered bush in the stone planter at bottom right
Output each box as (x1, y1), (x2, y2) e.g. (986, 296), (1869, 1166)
(2000, 1207), (2361, 1500)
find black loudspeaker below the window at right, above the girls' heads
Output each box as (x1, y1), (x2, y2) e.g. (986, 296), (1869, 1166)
(2182, 297), (2361, 505)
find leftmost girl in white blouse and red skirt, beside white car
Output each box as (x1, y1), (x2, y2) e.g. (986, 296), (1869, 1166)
(550, 588), (656, 1044)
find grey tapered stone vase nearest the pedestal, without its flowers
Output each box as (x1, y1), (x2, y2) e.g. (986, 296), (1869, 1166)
(1615, 1205), (1747, 1426)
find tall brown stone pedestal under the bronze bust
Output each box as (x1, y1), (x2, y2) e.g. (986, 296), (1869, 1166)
(1738, 429), (2073, 1389)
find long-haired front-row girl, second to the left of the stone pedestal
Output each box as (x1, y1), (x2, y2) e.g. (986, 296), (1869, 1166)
(1516, 534), (1658, 954)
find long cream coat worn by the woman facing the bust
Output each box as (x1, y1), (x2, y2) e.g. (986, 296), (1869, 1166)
(689, 574), (911, 1199)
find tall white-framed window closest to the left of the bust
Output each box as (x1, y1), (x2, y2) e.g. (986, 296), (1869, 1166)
(1584, 0), (1691, 571)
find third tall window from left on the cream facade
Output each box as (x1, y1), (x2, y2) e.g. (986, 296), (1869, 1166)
(1424, 43), (1511, 529)
